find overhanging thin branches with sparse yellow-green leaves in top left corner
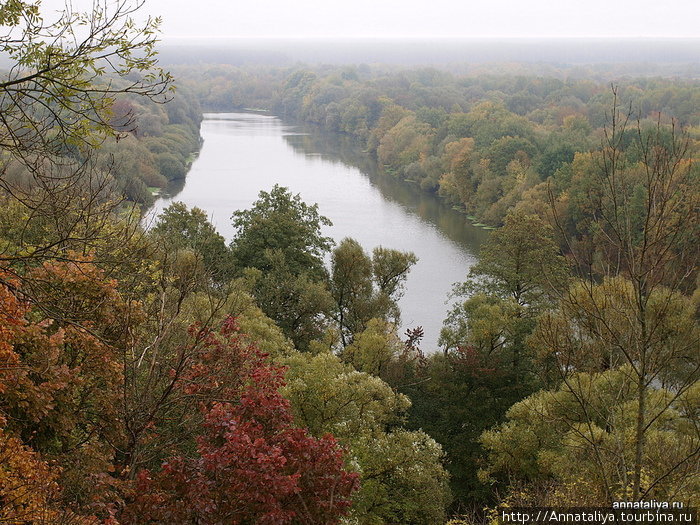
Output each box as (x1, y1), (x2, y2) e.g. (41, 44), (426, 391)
(0, 0), (171, 159)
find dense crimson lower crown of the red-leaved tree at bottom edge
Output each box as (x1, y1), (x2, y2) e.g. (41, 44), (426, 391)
(131, 404), (357, 525)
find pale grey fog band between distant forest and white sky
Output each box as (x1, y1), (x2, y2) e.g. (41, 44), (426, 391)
(160, 38), (700, 71)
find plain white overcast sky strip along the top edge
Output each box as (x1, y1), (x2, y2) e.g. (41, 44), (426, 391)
(38, 0), (700, 38)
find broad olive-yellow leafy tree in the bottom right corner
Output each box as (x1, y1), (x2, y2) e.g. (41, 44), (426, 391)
(481, 365), (700, 506)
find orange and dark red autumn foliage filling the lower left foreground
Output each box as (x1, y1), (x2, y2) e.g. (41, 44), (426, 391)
(0, 268), (358, 525)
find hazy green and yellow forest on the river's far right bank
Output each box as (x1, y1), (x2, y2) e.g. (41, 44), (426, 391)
(171, 65), (700, 226)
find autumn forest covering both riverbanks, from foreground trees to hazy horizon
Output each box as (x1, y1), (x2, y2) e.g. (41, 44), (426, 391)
(0, 1), (700, 525)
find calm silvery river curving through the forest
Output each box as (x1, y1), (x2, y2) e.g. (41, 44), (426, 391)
(153, 113), (488, 353)
